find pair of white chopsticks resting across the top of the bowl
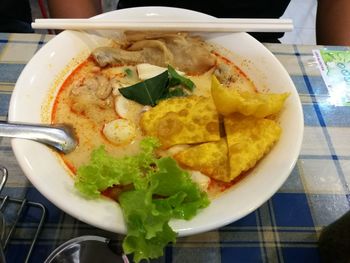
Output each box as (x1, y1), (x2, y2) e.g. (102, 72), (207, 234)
(32, 18), (293, 32)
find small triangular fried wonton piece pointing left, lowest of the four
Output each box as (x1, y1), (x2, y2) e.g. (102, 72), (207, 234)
(173, 138), (231, 182)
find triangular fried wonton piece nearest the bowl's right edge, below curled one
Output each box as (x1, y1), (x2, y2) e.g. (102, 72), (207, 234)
(224, 114), (281, 180)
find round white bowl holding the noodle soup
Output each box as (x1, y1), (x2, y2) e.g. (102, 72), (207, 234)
(9, 7), (303, 236)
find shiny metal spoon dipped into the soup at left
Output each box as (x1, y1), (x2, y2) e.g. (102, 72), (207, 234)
(0, 122), (78, 154)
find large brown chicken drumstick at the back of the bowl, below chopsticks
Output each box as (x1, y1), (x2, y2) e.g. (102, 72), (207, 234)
(92, 32), (216, 74)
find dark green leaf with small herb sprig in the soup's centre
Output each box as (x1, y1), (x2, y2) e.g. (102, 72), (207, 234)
(119, 65), (195, 106)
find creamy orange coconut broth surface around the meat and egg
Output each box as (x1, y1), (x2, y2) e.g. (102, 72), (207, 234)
(52, 42), (256, 195)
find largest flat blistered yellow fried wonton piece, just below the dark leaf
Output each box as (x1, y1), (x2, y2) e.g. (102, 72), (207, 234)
(140, 96), (220, 149)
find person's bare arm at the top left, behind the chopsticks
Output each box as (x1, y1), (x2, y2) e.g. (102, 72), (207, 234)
(48, 0), (102, 18)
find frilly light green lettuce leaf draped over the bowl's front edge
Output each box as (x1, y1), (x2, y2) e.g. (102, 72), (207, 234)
(75, 138), (209, 262)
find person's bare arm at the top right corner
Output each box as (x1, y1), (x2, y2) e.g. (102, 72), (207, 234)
(316, 0), (350, 46)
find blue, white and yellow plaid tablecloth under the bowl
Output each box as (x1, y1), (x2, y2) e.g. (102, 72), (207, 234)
(0, 34), (350, 263)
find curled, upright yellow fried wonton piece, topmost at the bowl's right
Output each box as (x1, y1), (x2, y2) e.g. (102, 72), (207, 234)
(211, 75), (289, 118)
